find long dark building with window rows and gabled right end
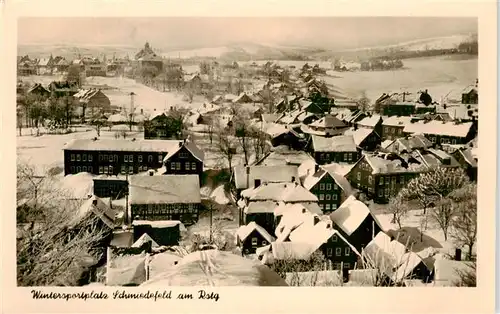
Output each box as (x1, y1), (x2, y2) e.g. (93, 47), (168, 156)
(63, 138), (204, 179)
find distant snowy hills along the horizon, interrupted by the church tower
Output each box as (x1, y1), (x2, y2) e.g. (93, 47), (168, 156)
(18, 34), (477, 61)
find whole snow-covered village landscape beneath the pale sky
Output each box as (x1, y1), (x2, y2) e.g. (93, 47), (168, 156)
(16, 17), (479, 287)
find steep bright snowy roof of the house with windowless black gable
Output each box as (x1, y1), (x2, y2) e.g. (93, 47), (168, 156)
(330, 195), (382, 236)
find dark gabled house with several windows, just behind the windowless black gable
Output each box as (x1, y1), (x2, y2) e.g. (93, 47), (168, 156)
(302, 164), (353, 213)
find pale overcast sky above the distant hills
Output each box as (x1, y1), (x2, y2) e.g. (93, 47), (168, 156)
(18, 17), (477, 50)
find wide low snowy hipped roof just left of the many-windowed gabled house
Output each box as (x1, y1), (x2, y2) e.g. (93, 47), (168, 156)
(241, 182), (318, 203)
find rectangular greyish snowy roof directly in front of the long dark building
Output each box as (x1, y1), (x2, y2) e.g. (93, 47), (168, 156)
(129, 174), (201, 204)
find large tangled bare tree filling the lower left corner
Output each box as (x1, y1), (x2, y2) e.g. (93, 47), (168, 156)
(17, 164), (111, 286)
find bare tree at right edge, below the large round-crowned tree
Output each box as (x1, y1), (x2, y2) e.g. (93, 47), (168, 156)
(451, 183), (477, 259)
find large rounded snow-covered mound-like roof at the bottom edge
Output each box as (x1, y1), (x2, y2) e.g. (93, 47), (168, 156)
(142, 250), (287, 287)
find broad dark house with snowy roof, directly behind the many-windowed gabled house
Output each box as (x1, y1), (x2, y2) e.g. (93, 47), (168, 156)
(309, 135), (358, 165)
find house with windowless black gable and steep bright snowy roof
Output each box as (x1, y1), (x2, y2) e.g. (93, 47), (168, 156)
(330, 195), (382, 251)
